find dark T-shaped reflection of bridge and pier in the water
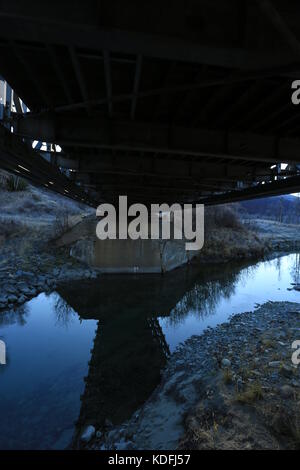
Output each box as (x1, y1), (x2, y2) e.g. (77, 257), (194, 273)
(56, 263), (251, 438)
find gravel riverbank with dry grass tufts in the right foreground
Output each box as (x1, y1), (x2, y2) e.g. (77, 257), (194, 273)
(85, 302), (300, 450)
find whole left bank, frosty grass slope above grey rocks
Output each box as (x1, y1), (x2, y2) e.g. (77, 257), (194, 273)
(0, 187), (98, 310)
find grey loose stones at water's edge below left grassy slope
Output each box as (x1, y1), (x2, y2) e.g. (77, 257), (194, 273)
(0, 227), (99, 312)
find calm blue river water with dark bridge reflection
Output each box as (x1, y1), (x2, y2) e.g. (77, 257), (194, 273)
(0, 254), (300, 449)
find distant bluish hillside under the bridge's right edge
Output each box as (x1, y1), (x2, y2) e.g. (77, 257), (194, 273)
(239, 195), (300, 224)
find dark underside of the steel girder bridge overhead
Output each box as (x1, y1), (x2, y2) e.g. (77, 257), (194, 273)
(0, 0), (300, 206)
